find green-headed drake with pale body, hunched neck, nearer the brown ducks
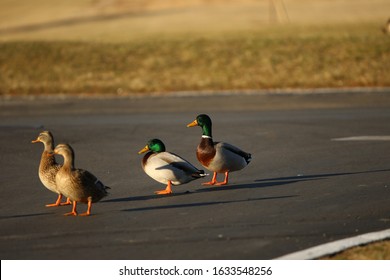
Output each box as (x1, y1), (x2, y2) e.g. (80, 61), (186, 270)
(138, 139), (207, 194)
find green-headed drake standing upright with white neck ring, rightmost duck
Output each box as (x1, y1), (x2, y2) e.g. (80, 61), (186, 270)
(187, 114), (252, 186)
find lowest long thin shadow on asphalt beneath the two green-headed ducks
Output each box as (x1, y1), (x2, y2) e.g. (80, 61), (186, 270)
(121, 195), (297, 212)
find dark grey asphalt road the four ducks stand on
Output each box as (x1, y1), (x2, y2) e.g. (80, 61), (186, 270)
(0, 91), (390, 260)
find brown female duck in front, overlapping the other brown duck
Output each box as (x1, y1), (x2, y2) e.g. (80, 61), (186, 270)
(51, 144), (109, 216)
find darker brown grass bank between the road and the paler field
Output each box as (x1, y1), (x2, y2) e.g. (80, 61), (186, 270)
(0, 25), (390, 94)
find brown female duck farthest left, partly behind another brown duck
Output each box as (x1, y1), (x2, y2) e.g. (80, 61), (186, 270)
(31, 131), (71, 207)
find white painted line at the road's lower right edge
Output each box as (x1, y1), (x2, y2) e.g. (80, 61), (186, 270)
(276, 229), (390, 260)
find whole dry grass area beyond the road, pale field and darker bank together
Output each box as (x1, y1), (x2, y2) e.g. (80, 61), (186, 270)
(0, 0), (390, 94)
